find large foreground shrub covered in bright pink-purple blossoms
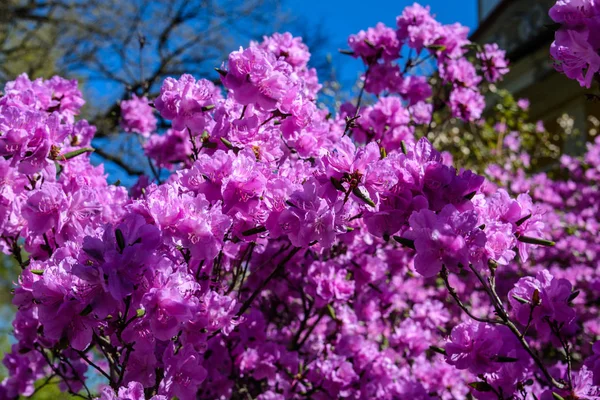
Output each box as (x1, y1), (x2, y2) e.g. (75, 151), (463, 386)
(0, 4), (600, 400)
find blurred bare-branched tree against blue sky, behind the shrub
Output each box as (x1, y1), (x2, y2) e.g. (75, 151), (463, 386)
(0, 0), (327, 176)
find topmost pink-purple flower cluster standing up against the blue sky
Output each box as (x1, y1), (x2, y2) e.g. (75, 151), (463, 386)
(344, 4), (508, 156)
